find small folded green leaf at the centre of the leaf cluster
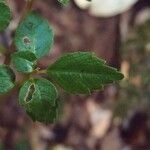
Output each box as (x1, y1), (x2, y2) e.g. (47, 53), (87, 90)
(11, 51), (37, 73)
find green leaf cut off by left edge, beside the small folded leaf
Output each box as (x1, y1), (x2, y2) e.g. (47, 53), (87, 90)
(0, 65), (15, 94)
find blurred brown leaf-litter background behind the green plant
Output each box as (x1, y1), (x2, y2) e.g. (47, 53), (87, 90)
(0, 0), (150, 150)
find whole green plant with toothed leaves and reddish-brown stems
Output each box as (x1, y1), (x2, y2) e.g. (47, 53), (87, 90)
(0, 0), (123, 123)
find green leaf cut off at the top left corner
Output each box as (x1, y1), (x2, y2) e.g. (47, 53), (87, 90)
(0, 0), (11, 31)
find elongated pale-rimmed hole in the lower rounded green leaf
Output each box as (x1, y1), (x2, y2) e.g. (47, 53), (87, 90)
(25, 84), (35, 102)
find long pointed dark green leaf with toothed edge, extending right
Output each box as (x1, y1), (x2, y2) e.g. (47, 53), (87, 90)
(48, 52), (123, 94)
